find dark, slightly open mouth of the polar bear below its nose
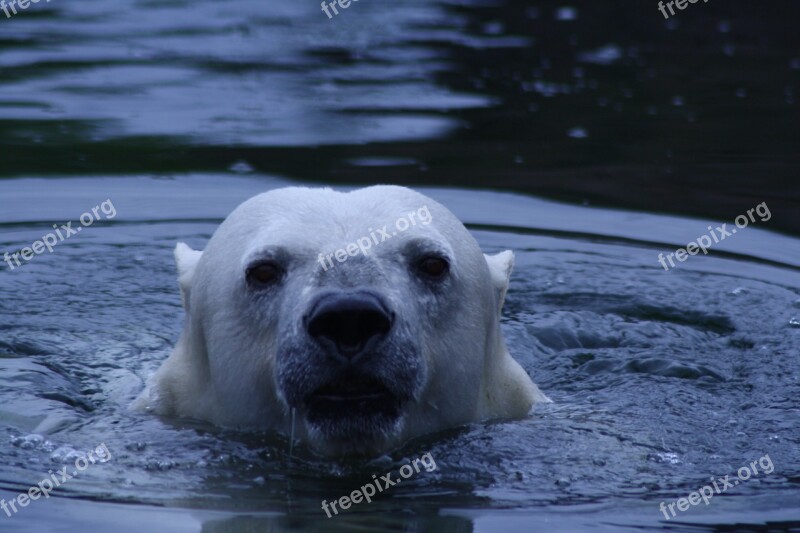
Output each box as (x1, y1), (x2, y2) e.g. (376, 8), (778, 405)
(305, 374), (402, 423)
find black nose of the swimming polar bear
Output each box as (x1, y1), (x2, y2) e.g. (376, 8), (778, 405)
(306, 292), (394, 362)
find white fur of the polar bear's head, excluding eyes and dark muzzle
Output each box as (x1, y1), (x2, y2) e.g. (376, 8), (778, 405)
(136, 186), (549, 453)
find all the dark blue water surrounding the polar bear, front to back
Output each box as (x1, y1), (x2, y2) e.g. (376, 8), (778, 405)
(0, 0), (800, 532)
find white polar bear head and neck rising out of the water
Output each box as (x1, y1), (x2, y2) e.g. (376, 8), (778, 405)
(136, 186), (550, 456)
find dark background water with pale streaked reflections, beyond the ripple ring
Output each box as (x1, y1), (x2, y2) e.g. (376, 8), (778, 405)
(0, 0), (800, 232)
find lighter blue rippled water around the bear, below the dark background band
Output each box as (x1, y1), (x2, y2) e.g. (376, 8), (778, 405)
(0, 175), (800, 531)
